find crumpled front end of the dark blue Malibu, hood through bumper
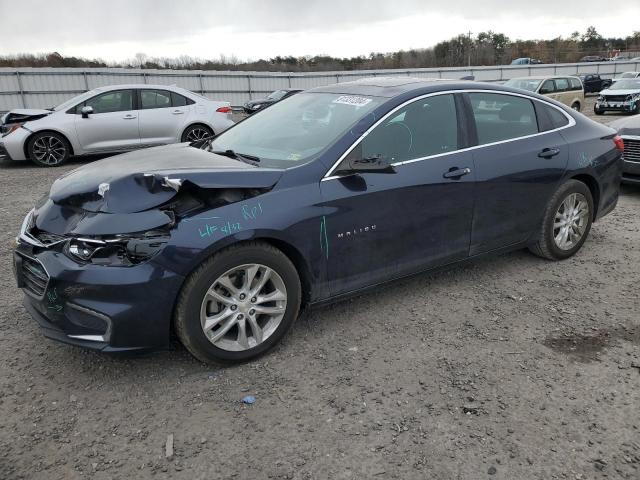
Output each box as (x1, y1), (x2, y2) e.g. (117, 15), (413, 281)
(14, 147), (282, 351)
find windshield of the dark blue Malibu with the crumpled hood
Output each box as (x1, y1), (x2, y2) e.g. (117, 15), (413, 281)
(207, 93), (386, 168)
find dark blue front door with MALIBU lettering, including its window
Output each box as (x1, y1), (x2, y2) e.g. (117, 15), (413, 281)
(320, 94), (474, 295)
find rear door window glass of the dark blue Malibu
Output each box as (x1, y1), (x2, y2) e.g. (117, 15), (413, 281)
(469, 93), (538, 145)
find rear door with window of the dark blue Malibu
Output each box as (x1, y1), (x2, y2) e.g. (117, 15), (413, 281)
(467, 92), (569, 255)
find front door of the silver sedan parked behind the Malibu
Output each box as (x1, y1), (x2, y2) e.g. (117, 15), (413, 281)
(75, 89), (140, 153)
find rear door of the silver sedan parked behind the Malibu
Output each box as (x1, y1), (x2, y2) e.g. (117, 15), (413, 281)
(138, 88), (190, 146)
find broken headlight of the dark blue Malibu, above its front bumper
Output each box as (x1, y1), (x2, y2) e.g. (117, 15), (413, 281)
(65, 232), (169, 266)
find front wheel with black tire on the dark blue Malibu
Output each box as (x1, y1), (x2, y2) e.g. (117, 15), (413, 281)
(174, 242), (302, 363)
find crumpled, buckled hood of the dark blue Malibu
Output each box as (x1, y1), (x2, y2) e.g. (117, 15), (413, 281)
(49, 143), (283, 213)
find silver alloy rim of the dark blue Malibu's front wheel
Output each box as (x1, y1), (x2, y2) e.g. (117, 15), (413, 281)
(200, 263), (287, 351)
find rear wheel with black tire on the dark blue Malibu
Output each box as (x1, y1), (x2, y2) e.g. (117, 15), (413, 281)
(529, 180), (594, 260)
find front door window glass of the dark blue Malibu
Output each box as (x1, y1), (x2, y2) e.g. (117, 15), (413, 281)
(354, 94), (458, 163)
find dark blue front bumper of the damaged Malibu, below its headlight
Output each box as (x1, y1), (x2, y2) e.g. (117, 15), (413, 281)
(14, 241), (184, 352)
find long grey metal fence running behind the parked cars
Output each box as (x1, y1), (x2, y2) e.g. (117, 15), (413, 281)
(0, 62), (640, 112)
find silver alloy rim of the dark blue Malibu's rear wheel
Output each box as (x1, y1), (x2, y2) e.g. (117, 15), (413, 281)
(553, 193), (590, 250)
